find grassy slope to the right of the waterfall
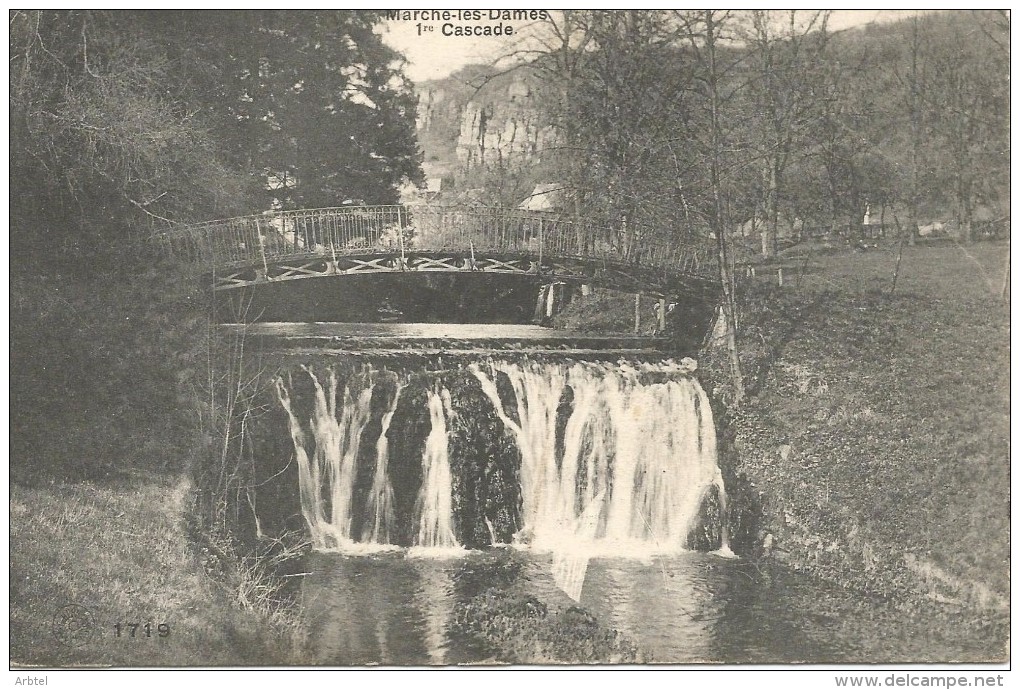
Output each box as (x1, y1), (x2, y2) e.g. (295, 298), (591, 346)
(732, 244), (1010, 611)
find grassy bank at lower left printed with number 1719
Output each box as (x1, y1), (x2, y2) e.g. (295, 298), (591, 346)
(10, 479), (300, 668)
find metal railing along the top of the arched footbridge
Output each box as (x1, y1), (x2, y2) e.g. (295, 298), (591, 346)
(158, 205), (713, 277)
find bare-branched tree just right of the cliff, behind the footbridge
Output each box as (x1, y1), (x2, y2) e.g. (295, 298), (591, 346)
(481, 10), (692, 239)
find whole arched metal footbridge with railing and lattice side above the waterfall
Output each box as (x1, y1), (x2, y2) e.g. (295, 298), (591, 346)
(157, 205), (715, 298)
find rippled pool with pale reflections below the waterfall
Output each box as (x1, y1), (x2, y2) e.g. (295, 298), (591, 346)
(302, 549), (1001, 666)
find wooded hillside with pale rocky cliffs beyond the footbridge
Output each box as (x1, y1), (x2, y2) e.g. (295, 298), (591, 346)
(417, 11), (1010, 232)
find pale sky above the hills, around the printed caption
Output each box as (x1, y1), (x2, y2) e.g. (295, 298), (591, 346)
(383, 9), (919, 83)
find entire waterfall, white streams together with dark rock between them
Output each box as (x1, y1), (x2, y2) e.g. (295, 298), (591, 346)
(276, 359), (728, 559)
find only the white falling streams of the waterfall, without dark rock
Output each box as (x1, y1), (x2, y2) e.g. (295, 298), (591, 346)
(276, 359), (729, 563)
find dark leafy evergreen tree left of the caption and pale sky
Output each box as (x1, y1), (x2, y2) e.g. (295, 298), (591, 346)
(157, 10), (422, 208)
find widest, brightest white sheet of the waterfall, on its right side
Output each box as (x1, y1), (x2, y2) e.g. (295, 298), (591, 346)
(470, 360), (725, 554)
